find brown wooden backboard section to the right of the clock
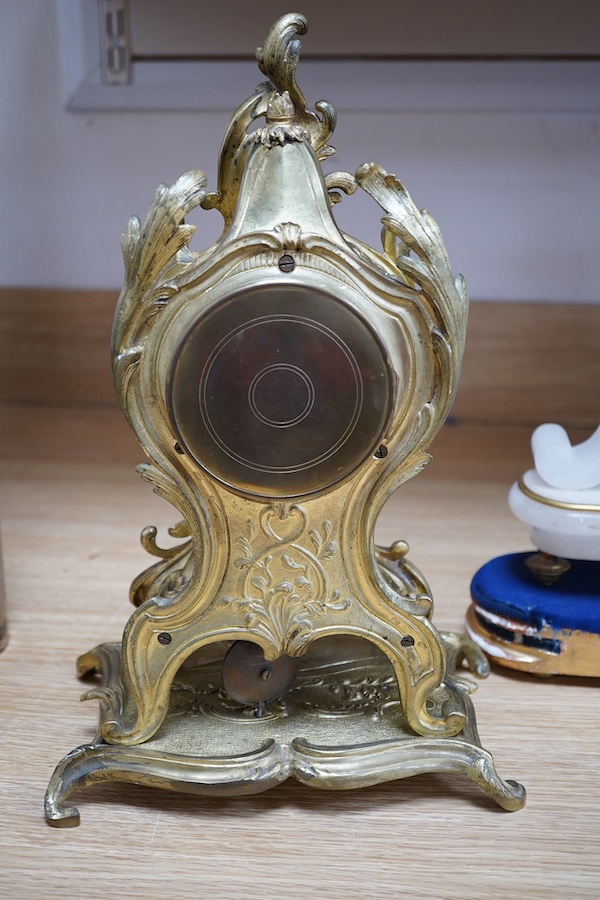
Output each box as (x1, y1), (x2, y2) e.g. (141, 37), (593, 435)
(453, 302), (600, 428)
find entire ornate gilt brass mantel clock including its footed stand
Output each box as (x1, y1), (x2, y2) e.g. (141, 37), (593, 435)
(46, 14), (524, 825)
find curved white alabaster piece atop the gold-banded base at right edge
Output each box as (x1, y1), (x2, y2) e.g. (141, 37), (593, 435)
(531, 424), (600, 491)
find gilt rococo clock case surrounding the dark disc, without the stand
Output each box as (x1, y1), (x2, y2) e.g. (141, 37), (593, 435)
(104, 15), (467, 744)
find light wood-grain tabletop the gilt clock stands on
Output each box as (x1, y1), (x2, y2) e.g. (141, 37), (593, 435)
(0, 405), (600, 900)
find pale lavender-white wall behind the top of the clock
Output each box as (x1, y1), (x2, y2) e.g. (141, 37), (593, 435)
(0, 0), (600, 302)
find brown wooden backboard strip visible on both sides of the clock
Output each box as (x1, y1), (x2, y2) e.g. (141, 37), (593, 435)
(0, 288), (600, 429)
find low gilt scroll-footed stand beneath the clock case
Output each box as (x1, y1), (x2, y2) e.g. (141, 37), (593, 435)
(45, 633), (525, 826)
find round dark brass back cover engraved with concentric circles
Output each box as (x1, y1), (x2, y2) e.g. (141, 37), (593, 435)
(170, 285), (390, 497)
